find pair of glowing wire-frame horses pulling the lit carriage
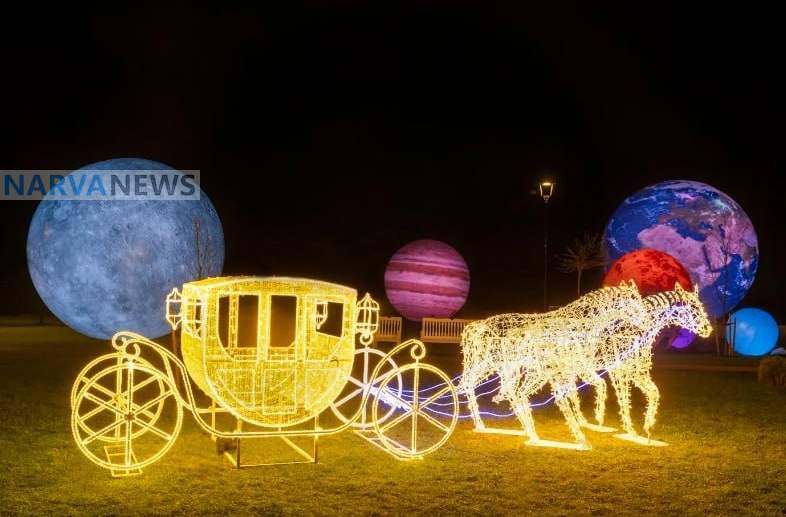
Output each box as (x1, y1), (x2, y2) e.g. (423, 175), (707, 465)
(458, 281), (712, 449)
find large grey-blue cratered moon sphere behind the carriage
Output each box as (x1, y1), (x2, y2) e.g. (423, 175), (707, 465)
(27, 158), (225, 339)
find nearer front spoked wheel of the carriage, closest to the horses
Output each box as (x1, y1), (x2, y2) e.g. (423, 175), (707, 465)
(372, 362), (459, 458)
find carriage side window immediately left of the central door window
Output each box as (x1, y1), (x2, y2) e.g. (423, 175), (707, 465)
(218, 294), (259, 349)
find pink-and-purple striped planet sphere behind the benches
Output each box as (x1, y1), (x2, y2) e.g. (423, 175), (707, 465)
(385, 239), (469, 321)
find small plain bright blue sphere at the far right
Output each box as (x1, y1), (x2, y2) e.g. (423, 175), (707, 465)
(726, 307), (779, 356)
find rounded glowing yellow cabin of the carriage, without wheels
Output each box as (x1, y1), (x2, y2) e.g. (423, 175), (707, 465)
(175, 277), (357, 427)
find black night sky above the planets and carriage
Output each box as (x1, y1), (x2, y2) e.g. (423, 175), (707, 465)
(0, 2), (786, 321)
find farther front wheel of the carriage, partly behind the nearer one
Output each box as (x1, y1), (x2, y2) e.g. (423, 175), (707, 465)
(330, 346), (401, 429)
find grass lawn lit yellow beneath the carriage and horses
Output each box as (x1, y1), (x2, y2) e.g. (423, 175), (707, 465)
(0, 324), (786, 517)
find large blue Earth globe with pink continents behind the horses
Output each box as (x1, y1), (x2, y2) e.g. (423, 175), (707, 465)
(604, 180), (759, 318)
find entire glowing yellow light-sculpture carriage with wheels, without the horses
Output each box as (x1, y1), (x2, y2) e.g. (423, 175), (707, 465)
(71, 277), (459, 476)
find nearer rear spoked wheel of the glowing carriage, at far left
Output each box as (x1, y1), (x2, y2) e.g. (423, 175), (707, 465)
(71, 361), (183, 475)
